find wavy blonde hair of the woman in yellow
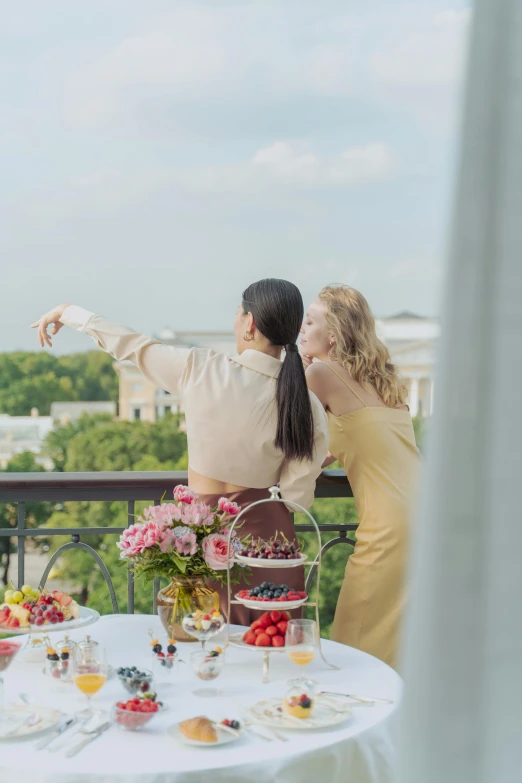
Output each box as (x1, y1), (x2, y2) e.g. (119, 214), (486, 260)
(319, 285), (407, 408)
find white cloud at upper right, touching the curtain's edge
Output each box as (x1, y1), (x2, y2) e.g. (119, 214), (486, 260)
(370, 9), (471, 88)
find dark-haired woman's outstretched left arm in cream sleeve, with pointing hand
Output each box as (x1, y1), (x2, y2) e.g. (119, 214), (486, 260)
(32, 304), (192, 393)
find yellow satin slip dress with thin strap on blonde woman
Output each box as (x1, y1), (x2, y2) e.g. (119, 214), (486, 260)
(326, 365), (420, 668)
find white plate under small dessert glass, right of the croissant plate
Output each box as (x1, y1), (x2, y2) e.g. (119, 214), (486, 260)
(245, 696), (352, 731)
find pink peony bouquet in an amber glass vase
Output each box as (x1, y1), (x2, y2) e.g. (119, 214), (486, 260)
(117, 485), (245, 641)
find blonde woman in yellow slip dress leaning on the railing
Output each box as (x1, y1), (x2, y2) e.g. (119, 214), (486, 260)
(301, 285), (419, 667)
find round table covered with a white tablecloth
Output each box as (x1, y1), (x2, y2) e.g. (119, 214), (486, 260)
(0, 615), (401, 783)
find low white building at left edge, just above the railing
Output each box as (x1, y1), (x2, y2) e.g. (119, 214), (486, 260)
(0, 408), (53, 470)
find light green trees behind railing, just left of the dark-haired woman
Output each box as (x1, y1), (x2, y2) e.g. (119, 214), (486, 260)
(42, 415), (187, 614)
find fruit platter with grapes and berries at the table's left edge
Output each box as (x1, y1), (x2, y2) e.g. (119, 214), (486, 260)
(0, 585), (100, 634)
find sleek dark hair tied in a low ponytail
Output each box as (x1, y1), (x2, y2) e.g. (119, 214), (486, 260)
(243, 278), (314, 459)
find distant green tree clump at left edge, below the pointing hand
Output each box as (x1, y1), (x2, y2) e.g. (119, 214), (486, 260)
(0, 351), (118, 416)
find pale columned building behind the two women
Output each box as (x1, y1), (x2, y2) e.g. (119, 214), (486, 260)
(115, 312), (440, 421)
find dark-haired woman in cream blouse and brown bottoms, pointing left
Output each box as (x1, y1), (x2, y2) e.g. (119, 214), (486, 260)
(33, 279), (328, 624)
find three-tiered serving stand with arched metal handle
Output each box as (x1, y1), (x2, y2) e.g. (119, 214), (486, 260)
(222, 487), (339, 683)
